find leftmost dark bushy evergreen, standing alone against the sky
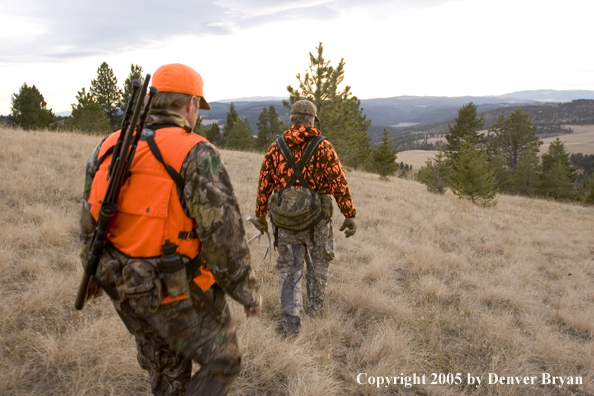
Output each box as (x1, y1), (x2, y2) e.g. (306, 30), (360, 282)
(8, 82), (55, 130)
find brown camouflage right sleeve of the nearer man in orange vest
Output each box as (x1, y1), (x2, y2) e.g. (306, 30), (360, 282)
(180, 142), (259, 307)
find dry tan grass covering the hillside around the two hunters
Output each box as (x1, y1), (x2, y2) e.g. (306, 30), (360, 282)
(0, 130), (594, 396)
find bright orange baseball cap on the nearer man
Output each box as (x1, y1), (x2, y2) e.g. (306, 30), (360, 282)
(153, 63), (210, 110)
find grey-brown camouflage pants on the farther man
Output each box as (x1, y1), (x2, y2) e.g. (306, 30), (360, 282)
(276, 220), (334, 333)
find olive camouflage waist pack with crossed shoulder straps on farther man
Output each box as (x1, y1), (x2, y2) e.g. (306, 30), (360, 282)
(268, 135), (326, 235)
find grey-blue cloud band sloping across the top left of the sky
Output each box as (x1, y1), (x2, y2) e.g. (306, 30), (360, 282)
(0, 0), (451, 64)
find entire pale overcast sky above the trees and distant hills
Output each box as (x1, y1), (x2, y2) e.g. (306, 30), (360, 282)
(0, 0), (594, 115)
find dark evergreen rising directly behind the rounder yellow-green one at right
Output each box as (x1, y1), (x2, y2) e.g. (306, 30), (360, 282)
(445, 102), (485, 158)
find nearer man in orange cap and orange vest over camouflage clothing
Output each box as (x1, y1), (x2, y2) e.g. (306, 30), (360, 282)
(80, 63), (262, 395)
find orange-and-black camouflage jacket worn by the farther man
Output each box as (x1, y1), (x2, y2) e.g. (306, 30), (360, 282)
(256, 126), (357, 217)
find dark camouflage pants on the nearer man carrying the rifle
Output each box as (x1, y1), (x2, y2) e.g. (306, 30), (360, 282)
(112, 287), (241, 396)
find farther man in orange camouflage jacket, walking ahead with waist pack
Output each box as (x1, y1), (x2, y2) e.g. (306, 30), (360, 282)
(253, 100), (357, 334)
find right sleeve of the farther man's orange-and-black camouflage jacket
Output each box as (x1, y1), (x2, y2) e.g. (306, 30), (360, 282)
(317, 140), (357, 218)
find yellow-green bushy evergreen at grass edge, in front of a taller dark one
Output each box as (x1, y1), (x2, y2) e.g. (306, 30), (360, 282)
(450, 141), (497, 206)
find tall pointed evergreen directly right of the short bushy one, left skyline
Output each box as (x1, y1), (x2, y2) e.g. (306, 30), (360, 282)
(89, 62), (122, 130)
